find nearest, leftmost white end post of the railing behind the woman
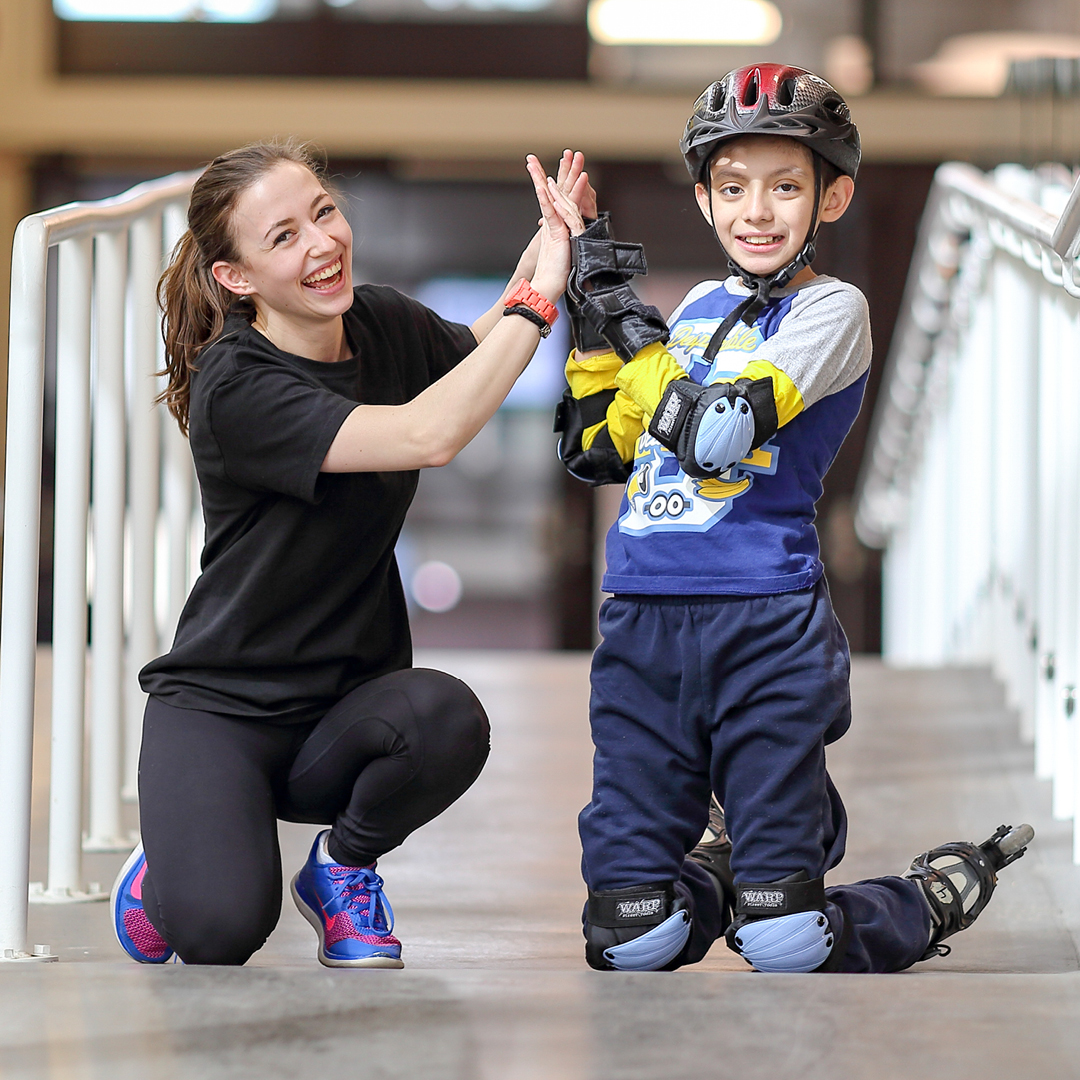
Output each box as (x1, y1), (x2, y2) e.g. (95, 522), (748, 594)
(0, 212), (55, 961)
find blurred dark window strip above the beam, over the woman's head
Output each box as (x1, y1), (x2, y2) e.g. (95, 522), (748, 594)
(53, 0), (589, 81)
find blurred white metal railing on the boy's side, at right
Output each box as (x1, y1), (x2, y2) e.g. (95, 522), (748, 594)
(856, 157), (1080, 862)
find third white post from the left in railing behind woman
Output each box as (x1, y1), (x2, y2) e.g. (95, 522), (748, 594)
(84, 229), (131, 851)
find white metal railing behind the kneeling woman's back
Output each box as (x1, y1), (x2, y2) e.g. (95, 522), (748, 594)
(0, 173), (198, 960)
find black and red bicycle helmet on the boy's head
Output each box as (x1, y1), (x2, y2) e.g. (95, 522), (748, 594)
(679, 64), (862, 181)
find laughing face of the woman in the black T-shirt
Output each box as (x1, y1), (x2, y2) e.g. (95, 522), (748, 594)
(213, 161), (352, 322)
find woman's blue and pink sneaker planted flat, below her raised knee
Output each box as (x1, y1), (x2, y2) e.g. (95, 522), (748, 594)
(292, 833), (405, 968)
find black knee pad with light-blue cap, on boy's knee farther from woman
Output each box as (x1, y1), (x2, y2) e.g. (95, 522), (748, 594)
(726, 873), (843, 972)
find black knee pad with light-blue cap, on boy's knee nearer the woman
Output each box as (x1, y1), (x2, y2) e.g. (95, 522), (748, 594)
(584, 882), (691, 971)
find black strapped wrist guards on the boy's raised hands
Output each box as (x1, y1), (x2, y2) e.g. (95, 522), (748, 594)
(566, 216), (667, 361)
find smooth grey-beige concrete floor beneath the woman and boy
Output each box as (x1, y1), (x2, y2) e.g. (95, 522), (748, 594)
(0, 652), (1080, 1080)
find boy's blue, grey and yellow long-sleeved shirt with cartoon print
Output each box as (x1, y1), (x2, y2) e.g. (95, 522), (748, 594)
(567, 276), (870, 596)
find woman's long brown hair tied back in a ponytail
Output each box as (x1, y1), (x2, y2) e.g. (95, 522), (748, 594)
(158, 139), (323, 435)
